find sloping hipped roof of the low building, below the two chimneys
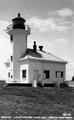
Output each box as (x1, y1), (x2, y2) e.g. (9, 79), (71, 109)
(19, 49), (67, 64)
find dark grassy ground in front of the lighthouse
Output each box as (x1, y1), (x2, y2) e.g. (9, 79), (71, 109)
(0, 86), (74, 120)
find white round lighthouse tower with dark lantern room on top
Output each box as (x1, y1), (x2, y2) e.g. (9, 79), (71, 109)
(7, 13), (30, 82)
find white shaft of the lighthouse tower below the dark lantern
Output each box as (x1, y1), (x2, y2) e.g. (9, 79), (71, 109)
(8, 29), (29, 82)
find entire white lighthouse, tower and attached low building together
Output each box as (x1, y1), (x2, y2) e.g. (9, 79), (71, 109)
(5, 13), (67, 87)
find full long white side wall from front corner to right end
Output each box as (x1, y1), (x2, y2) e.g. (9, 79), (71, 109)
(29, 61), (66, 83)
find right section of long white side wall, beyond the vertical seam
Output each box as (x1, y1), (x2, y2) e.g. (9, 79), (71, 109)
(44, 63), (65, 83)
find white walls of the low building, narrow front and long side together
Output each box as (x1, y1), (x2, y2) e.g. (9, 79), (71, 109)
(5, 60), (66, 83)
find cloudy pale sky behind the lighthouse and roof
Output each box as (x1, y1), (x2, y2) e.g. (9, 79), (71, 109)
(0, 0), (74, 80)
